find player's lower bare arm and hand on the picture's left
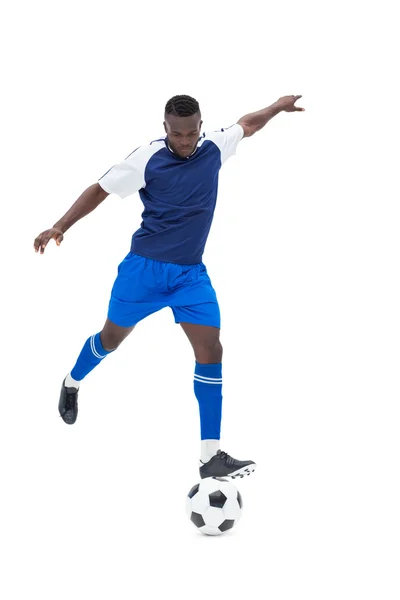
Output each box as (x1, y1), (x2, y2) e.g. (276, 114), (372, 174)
(33, 183), (109, 254)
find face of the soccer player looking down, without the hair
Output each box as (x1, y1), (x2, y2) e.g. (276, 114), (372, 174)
(164, 113), (203, 158)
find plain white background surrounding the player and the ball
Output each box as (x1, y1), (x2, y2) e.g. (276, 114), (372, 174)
(0, 0), (400, 600)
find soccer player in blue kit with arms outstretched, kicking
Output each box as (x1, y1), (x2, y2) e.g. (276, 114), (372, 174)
(34, 95), (304, 478)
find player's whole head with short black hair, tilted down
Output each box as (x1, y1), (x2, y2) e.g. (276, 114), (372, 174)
(164, 96), (203, 158)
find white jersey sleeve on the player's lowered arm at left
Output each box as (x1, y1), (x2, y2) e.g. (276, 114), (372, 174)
(98, 146), (150, 198)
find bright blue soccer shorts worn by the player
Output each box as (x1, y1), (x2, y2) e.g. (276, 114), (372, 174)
(107, 252), (221, 329)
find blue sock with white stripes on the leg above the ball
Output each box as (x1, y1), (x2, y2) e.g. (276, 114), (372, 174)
(194, 361), (222, 440)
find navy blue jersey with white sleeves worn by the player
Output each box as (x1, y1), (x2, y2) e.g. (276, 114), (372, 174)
(98, 123), (244, 265)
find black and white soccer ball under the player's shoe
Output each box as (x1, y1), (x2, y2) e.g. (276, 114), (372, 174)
(186, 477), (243, 535)
